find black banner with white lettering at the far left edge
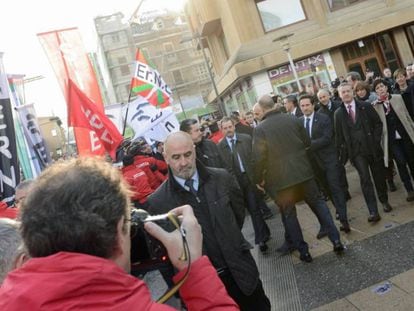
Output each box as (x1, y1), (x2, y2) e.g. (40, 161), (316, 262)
(0, 53), (20, 205)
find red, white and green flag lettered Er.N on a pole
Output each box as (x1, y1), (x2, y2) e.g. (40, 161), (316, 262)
(131, 49), (173, 108)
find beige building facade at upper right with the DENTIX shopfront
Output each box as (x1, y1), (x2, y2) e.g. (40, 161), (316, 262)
(185, 0), (414, 113)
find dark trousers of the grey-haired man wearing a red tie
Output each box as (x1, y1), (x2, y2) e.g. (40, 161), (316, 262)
(352, 155), (388, 215)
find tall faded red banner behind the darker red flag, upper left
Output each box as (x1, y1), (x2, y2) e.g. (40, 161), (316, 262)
(37, 28), (105, 155)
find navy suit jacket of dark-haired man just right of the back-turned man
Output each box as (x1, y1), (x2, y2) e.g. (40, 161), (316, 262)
(300, 112), (338, 169)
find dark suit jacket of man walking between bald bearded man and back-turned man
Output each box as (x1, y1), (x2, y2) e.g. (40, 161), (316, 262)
(218, 133), (253, 178)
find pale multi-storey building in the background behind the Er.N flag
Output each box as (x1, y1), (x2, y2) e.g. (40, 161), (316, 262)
(95, 11), (211, 113)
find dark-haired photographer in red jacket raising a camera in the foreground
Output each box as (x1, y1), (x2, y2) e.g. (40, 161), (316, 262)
(0, 158), (238, 311)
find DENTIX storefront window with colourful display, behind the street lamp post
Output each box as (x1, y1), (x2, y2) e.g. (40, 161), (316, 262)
(268, 54), (330, 97)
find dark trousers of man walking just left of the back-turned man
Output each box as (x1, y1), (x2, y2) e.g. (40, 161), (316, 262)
(237, 174), (270, 244)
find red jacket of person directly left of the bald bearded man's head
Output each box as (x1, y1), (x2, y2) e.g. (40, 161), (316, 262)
(134, 155), (168, 190)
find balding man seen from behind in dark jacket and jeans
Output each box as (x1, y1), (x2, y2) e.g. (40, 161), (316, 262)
(253, 95), (344, 262)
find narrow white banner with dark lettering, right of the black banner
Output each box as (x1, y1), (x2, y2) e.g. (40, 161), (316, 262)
(16, 104), (52, 169)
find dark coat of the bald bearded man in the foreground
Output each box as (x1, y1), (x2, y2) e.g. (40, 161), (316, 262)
(148, 163), (259, 295)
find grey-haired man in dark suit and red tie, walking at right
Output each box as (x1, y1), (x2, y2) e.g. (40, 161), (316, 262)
(334, 82), (392, 223)
